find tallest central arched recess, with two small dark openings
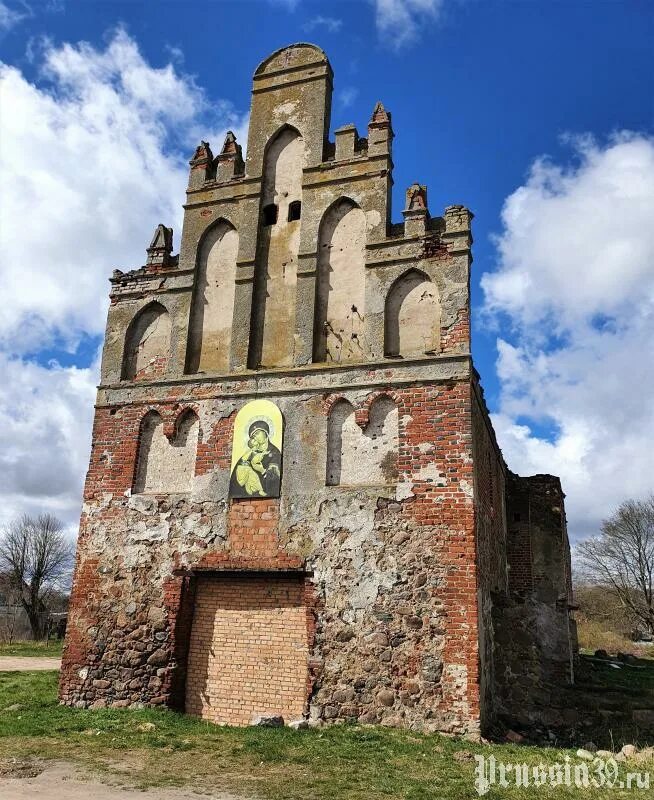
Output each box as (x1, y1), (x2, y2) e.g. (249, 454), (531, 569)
(248, 125), (305, 369)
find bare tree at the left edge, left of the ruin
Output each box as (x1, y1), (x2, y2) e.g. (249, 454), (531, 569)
(0, 514), (73, 639)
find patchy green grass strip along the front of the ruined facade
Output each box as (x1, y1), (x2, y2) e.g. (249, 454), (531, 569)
(0, 672), (654, 800)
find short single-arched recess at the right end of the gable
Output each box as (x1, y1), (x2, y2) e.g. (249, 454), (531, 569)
(384, 269), (441, 357)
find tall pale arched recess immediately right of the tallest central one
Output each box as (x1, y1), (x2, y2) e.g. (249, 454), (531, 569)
(313, 198), (366, 362)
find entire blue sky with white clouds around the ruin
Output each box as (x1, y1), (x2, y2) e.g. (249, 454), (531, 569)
(0, 0), (654, 536)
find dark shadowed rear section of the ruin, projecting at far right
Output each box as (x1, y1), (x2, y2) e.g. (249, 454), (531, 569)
(493, 473), (577, 725)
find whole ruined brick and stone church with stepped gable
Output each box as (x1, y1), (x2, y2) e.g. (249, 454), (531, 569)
(60, 44), (576, 735)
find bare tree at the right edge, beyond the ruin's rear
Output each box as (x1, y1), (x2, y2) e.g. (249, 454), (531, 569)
(577, 495), (654, 633)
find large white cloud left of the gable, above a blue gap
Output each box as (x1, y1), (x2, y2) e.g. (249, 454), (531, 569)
(0, 30), (241, 351)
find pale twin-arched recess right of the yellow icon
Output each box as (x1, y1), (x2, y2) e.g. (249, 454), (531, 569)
(326, 395), (399, 486)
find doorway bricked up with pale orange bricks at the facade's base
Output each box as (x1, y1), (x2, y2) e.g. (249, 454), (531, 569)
(186, 573), (309, 725)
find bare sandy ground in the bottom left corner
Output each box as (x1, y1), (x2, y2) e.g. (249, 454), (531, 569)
(0, 763), (247, 800)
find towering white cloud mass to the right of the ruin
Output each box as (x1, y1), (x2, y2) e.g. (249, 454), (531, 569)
(482, 132), (654, 537)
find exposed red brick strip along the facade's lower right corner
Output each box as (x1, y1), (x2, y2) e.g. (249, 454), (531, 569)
(393, 382), (479, 719)
